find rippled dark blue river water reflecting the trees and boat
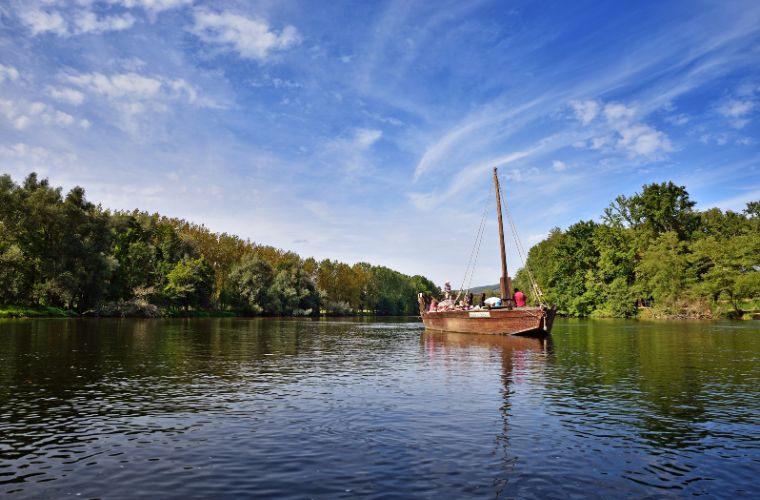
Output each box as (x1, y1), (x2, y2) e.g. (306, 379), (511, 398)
(0, 319), (760, 499)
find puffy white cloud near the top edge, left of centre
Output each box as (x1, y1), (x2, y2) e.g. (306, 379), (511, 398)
(191, 9), (300, 61)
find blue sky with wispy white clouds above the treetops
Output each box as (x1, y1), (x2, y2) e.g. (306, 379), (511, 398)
(0, 0), (760, 286)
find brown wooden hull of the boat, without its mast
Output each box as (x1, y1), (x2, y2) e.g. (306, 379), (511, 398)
(422, 307), (556, 336)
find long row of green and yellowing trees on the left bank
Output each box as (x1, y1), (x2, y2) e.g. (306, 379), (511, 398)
(0, 174), (436, 316)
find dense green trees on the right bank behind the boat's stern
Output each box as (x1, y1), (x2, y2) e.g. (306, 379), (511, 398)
(515, 182), (760, 317)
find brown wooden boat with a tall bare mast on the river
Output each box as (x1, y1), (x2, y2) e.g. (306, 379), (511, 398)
(420, 168), (556, 336)
